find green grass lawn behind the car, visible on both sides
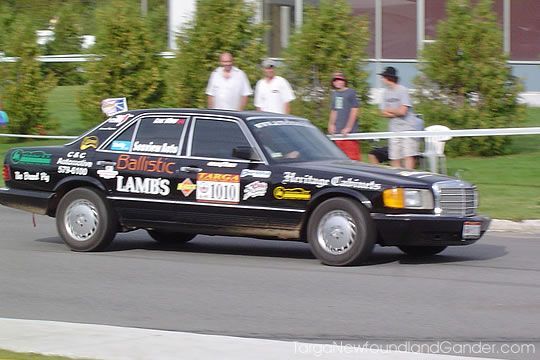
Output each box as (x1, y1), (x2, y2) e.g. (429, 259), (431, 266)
(0, 86), (540, 221)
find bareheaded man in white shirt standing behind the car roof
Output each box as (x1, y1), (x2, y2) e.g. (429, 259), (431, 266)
(206, 52), (253, 110)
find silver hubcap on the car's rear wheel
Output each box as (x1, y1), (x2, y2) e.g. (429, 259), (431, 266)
(64, 200), (99, 241)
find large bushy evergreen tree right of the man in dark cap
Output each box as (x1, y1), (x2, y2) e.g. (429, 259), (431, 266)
(416, 0), (524, 155)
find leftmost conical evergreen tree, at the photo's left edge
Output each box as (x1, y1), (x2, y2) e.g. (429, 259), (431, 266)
(2, 16), (55, 134)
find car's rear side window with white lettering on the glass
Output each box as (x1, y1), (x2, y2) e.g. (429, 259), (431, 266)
(131, 115), (187, 155)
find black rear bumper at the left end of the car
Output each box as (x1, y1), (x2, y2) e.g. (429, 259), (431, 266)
(0, 188), (54, 215)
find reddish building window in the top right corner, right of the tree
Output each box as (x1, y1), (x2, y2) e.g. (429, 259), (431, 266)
(510, 0), (540, 61)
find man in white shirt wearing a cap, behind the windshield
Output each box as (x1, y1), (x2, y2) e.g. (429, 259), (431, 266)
(255, 59), (296, 114)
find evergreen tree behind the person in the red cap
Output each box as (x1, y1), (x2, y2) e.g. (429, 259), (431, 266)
(284, 0), (374, 131)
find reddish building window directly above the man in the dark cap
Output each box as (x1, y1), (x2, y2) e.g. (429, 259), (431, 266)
(382, 0), (416, 59)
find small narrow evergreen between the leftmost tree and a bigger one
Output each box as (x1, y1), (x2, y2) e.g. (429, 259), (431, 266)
(45, 4), (82, 85)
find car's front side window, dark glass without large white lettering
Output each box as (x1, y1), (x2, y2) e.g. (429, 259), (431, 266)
(191, 119), (250, 159)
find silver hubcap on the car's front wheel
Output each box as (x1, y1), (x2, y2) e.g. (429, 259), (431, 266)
(317, 210), (356, 255)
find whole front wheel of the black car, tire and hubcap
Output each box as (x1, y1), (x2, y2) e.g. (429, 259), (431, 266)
(307, 197), (376, 266)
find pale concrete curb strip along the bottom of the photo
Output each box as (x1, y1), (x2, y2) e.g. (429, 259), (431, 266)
(0, 318), (502, 360)
